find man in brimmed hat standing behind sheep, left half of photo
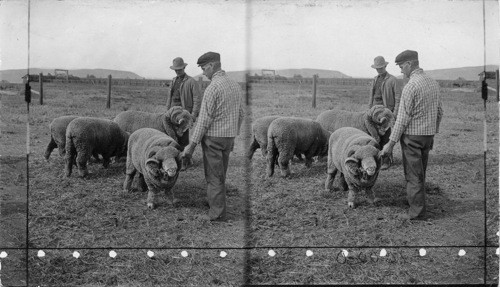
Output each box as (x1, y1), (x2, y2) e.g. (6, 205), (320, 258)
(167, 57), (201, 154)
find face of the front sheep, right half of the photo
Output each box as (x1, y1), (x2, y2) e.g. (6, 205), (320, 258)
(345, 145), (380, 184)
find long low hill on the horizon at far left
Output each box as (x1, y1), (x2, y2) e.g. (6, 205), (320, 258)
(0, 68), (143, 83)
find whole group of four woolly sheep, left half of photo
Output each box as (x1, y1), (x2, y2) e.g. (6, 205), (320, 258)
(44, 107), (193, 208)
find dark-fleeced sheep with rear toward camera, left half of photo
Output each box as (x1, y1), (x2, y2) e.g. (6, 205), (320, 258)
(66, 117), (129, 177)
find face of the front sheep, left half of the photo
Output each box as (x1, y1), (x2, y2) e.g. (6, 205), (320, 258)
(146, 146), (180, 182)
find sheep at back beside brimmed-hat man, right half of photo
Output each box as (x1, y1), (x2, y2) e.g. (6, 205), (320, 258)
(316, 105), (395, 145)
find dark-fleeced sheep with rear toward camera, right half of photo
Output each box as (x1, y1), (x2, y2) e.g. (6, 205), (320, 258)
(267, 117), (330, 177)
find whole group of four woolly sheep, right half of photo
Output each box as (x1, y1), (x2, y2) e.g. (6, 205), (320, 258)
(248, 105), (395, 207)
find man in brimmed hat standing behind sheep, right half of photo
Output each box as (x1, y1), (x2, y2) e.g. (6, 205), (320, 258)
(369, 56), (401, 168)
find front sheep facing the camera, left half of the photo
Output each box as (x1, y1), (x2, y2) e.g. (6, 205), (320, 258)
(123, 128), (181, 209)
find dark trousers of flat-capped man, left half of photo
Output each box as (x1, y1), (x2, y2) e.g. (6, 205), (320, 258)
(201, 136), (234, 220)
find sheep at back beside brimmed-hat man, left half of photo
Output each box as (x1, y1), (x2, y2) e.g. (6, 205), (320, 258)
(114, 106), (193, 147)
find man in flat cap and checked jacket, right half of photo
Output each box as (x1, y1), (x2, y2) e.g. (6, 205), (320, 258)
(381, 50), (443, 220)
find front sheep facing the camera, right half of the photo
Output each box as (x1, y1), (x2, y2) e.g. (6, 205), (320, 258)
(325, 127), (381, 208)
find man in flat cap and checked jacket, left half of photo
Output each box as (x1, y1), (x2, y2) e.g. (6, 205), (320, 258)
(181, 52), (244, 221)
